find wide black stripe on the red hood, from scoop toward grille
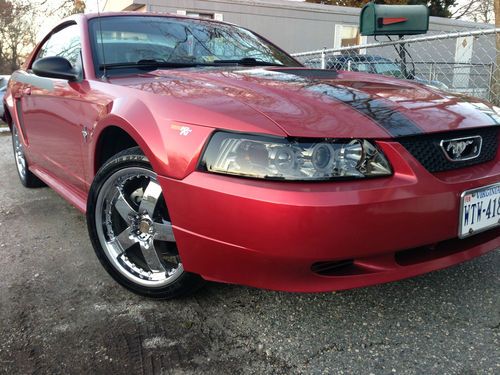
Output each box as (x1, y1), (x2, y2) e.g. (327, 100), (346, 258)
(308, 83), (423, 137)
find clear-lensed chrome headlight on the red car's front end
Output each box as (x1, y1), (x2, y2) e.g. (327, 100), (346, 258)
(200, 132), (392, 181)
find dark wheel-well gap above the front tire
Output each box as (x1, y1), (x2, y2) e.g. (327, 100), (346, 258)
(94, 126), (138, 175)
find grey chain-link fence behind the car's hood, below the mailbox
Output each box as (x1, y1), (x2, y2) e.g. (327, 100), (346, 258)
(293, 28), (500, 104)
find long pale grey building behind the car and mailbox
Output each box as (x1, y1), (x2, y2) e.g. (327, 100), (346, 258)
(103, 0), (492, 53)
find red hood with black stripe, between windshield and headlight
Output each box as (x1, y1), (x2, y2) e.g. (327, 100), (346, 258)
(112, 68), (500, 138)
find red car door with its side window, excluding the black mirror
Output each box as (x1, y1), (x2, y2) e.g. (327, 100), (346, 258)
(22, 24), (87, 192)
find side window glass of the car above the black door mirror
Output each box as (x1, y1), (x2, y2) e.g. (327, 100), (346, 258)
(35, 25), (82, 71)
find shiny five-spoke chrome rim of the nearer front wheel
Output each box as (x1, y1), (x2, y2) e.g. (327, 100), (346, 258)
(95, 167), (183, 288)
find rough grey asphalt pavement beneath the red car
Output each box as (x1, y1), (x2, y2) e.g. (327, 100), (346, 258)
(0, 136), (500, 374)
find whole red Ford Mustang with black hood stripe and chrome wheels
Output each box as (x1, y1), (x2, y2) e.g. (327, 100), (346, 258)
(4, 13), (500, 298)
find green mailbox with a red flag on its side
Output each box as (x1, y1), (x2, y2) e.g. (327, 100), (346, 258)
(359, 3), (429, 35)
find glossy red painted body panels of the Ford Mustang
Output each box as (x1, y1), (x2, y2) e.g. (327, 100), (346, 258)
(5, 13), (500, 291)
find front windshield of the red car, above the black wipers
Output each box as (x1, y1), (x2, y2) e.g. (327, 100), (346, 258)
(90, 16), (300, 74)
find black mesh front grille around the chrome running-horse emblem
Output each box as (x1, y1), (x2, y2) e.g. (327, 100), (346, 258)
(397, 126), (500, 173)
